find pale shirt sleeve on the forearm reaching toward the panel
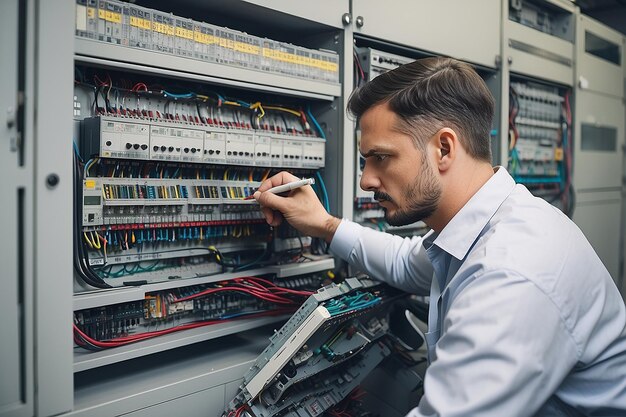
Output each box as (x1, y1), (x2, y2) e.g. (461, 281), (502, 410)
(330, 219), (433, 295)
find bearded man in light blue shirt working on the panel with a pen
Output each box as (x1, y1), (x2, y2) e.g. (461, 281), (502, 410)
(255, 58), (626, 417)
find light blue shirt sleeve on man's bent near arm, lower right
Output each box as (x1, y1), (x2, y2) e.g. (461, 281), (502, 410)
(407, 271), (580, 417)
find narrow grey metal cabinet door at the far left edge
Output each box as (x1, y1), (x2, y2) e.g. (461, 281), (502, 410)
(0, 0), (33, 416)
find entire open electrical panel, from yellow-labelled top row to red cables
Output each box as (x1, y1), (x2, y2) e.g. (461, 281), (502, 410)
(73, 0), (341, 400)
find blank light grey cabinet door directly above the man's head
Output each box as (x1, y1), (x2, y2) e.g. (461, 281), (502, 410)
(352, 0), (501, 68)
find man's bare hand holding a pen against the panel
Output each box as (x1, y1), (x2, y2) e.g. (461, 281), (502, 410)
(254, 171), (341, 243)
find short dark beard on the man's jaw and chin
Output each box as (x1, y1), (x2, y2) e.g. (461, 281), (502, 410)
(374, 160), (441, 226)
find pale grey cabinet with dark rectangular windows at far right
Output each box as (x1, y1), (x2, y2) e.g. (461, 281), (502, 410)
(574, 15), (626, 285)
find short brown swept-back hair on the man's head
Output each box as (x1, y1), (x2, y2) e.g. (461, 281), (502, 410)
(348, 57), (495, 162)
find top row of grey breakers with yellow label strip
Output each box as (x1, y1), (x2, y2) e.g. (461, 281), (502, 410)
(76, 0), (339, 84)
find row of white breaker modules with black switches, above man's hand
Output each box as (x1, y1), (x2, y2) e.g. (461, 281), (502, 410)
(81, 116), (325, 169)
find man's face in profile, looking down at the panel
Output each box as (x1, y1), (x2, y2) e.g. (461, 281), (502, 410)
(359, 104), (441, 226)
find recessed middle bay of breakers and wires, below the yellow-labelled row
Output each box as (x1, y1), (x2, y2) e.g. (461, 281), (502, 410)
(75, 62), (334, 288)
